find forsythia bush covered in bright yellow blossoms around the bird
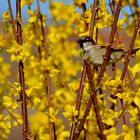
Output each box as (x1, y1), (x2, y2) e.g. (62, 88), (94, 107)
(0, 0), (140, 140)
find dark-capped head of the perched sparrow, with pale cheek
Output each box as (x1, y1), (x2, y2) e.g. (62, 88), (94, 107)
(77, 36), (95, 51)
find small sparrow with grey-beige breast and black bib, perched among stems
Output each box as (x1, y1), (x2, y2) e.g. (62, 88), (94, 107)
(77, 36), (140, 67)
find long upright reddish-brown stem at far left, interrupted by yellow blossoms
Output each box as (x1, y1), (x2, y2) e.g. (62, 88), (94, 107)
(16, 0), (29, 140)
